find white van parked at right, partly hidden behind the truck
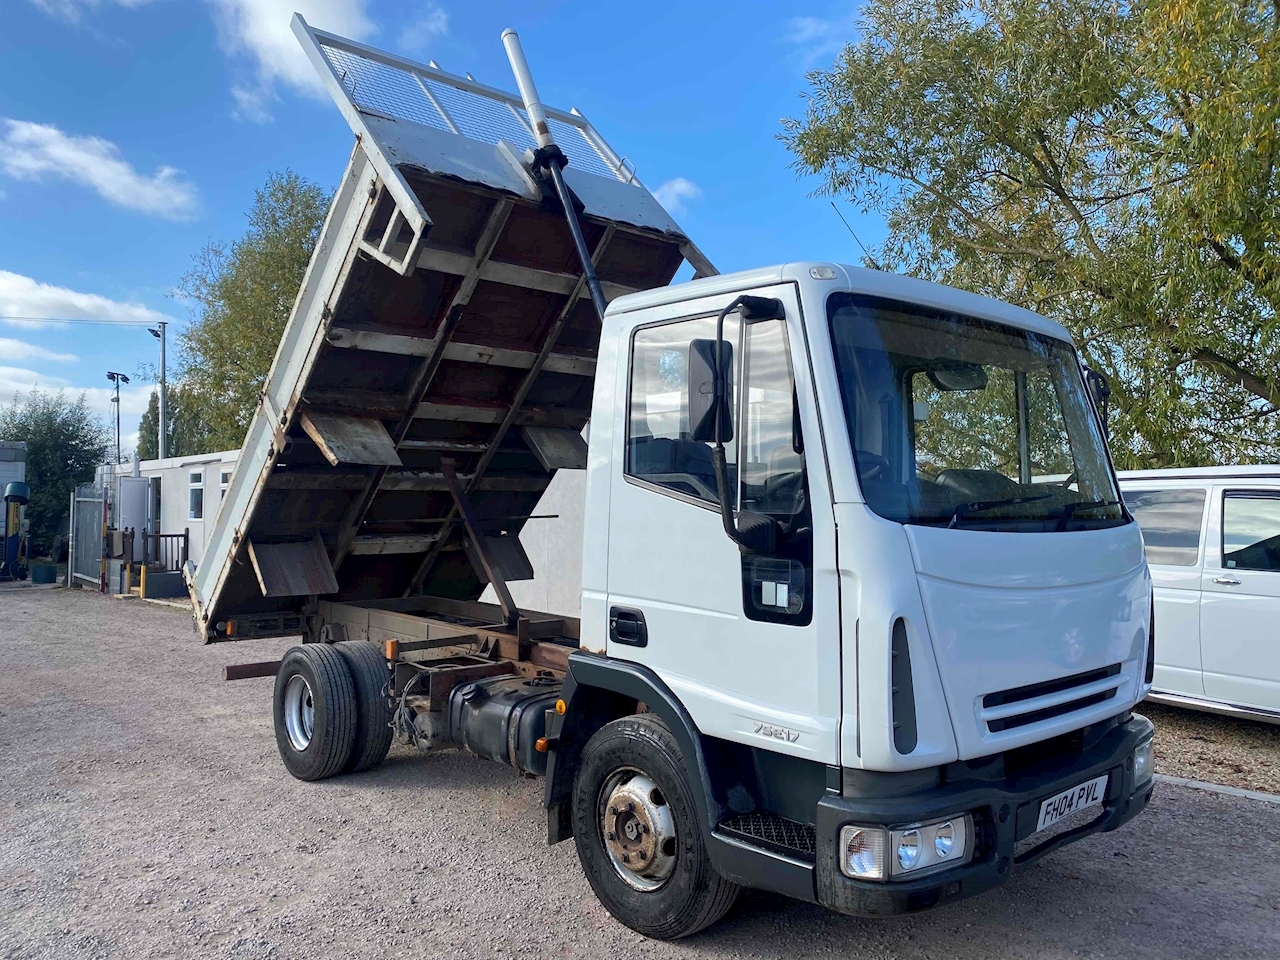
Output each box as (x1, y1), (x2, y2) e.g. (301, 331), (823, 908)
(1117, 466), (1280, 723)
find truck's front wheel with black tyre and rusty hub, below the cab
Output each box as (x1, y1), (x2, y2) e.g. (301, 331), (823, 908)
(573, 714), (740, 940)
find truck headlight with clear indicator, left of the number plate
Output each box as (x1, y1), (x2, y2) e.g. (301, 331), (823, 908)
(840, 813), (973, 881)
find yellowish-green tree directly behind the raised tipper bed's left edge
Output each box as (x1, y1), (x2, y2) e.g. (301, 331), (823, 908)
(178, 170), (329, 452)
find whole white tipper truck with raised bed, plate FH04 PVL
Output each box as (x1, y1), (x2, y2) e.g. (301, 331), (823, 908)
(187, 18), (1153, 938)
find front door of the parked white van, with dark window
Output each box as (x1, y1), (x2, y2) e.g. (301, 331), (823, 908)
(1198, 486), (1280, 712)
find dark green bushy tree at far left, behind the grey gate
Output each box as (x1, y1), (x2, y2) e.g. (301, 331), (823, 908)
(0, 389), (114, 553)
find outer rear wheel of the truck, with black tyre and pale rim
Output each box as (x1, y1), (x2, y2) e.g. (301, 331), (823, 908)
(273, 644), (356, 780)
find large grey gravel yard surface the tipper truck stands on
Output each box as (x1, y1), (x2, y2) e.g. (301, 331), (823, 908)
(0, 589), (1280, 960)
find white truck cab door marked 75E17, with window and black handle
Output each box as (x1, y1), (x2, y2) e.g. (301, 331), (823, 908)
(607, 284), (840, 764)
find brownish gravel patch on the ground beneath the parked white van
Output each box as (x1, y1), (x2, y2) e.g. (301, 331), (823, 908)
(1139, 703), (1280, 798)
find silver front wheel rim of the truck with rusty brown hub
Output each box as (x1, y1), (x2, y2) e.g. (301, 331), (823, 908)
(600, 769), (677, 892)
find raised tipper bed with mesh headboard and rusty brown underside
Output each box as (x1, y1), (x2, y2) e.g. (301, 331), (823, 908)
(187, 17), (714, 641)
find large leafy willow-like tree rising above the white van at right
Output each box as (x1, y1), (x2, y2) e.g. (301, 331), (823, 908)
(783, 0), (1280, 466)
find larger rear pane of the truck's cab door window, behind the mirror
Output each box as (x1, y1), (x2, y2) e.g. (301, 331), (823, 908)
(626, 316), (737, 504)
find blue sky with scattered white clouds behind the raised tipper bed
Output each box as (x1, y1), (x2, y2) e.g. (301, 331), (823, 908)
(0, 0), (883, 451)
